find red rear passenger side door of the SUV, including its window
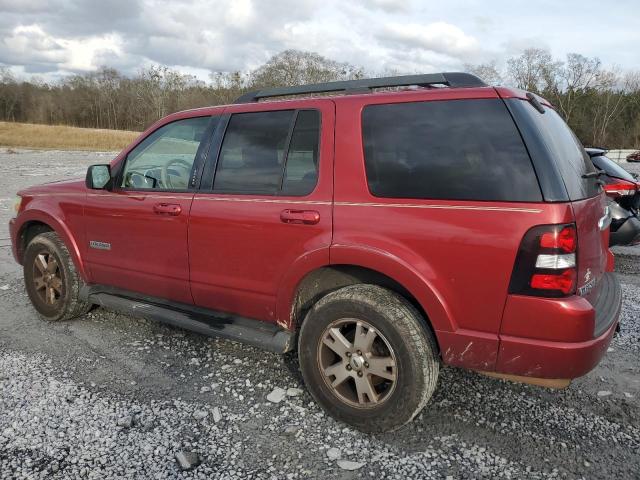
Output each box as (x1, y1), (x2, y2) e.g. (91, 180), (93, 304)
(189, 99), (334, 322)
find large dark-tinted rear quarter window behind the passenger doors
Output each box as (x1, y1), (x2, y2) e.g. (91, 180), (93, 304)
(362, 100), (542, 202)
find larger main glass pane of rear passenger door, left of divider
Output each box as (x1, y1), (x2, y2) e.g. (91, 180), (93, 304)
(213, 110), (294, 195)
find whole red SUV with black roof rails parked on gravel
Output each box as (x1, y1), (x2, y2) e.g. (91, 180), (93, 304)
(11, 73), (621, 431)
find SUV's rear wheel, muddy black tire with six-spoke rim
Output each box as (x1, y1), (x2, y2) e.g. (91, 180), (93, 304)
(298, 284), (439, 433)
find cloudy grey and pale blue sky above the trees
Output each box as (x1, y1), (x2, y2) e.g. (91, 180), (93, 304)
(0, 0), (640, 79)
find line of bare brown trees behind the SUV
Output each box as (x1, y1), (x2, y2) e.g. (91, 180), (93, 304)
(0, 49), (640, 148)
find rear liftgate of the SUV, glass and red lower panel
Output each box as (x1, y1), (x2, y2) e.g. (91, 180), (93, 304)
(510, 100), (609, 305)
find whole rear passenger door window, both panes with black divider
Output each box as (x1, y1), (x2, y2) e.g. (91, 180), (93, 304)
(213, 110), (320, 196)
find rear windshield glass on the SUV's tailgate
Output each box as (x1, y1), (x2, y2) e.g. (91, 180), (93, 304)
(523, 101), (600, 200)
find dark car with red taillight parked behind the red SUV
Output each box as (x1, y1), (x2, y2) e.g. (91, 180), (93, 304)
(585, 148), (640, 246)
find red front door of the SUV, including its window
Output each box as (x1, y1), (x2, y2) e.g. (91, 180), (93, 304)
(84, 117), (214, 303)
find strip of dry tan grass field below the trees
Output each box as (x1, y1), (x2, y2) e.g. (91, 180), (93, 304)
(0, 122), (139, 151)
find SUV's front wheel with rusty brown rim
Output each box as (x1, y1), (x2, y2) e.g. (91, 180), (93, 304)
(23, 232), (91, 321)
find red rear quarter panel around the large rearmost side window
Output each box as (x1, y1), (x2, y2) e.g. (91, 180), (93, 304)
(331, 89), (572, 370)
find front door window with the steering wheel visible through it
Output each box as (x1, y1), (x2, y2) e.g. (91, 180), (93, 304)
(120, 117), (210, 190)
